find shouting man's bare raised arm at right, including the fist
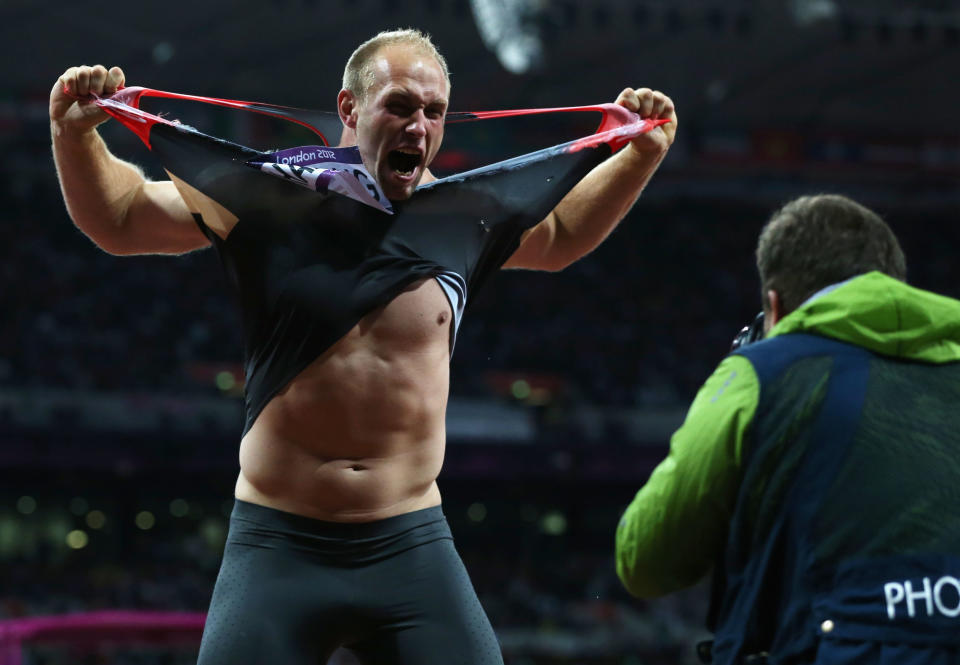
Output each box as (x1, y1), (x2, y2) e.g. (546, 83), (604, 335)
(504, 88), (677, 271)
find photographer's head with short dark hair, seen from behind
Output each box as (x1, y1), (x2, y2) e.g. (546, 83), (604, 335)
(757, 194), (907, 331)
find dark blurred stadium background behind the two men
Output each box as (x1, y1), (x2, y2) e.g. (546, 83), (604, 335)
(0, 0), (960, 665)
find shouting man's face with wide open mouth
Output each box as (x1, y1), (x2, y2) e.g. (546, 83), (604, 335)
(341, 44), (450, 200)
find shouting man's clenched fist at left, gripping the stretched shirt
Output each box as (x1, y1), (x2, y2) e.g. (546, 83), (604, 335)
(50, 65), (124, 133)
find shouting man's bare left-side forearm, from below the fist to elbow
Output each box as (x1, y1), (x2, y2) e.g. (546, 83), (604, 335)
(50, 122), (145, 252)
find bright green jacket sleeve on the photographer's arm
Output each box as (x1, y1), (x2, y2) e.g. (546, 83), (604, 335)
(616, 356), (759, 596)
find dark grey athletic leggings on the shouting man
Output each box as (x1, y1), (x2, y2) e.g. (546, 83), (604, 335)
(198, 500), (503, 665)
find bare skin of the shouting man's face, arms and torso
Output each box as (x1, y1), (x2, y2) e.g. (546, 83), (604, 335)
(50, 44), (676, 522)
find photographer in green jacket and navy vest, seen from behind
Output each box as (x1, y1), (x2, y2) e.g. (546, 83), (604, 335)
(616, 195), (960, 665)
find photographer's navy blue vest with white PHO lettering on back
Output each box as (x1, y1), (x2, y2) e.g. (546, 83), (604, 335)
(708, 334), (960, 665)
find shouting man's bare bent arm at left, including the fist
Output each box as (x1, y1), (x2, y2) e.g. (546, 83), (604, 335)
(50, 65), (210, 254)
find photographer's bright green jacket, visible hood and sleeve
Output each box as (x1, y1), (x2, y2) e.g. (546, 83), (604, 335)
(616, 272), (960, 597)
